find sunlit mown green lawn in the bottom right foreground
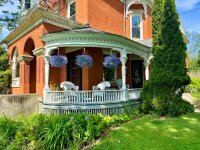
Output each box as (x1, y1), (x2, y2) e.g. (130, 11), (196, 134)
(91, 113), (200, 150)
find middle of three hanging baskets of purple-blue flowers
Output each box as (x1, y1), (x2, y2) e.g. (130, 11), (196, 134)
(76, 55), (93, 68)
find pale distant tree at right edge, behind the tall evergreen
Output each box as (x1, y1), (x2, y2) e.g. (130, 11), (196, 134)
(186, 32), (200, 71)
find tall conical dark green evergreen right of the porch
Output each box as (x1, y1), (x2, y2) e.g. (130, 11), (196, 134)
(142, 0), (193, 116)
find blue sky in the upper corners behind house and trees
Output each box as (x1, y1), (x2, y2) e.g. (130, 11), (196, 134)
(0, 0), (200, 38)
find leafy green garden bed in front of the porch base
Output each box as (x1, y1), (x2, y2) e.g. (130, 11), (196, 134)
(0, 113), (135, 150)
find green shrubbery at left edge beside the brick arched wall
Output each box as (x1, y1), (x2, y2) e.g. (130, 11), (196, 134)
(0, 44), (10, 94)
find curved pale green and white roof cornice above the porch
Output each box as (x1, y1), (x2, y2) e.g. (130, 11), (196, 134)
(41, 28), (151, 58)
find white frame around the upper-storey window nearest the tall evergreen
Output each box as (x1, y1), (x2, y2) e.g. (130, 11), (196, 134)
(130, 14), (143, 40)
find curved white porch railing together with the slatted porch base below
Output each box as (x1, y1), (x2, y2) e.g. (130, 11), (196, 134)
(43, 89), (141, 115)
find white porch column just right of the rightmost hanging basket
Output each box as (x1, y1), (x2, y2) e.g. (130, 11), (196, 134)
(120, 50), (127, 90)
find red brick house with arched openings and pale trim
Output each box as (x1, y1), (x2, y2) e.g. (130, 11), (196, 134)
(4, 0), (153, 114)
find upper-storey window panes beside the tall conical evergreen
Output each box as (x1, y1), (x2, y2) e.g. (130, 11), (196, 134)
(131, 15), (143, 39)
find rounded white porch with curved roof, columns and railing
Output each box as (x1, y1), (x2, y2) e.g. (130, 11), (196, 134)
(42, 29), (151, 115)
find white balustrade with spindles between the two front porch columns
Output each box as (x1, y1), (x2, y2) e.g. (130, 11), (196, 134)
(45, 90), (125, 104)
